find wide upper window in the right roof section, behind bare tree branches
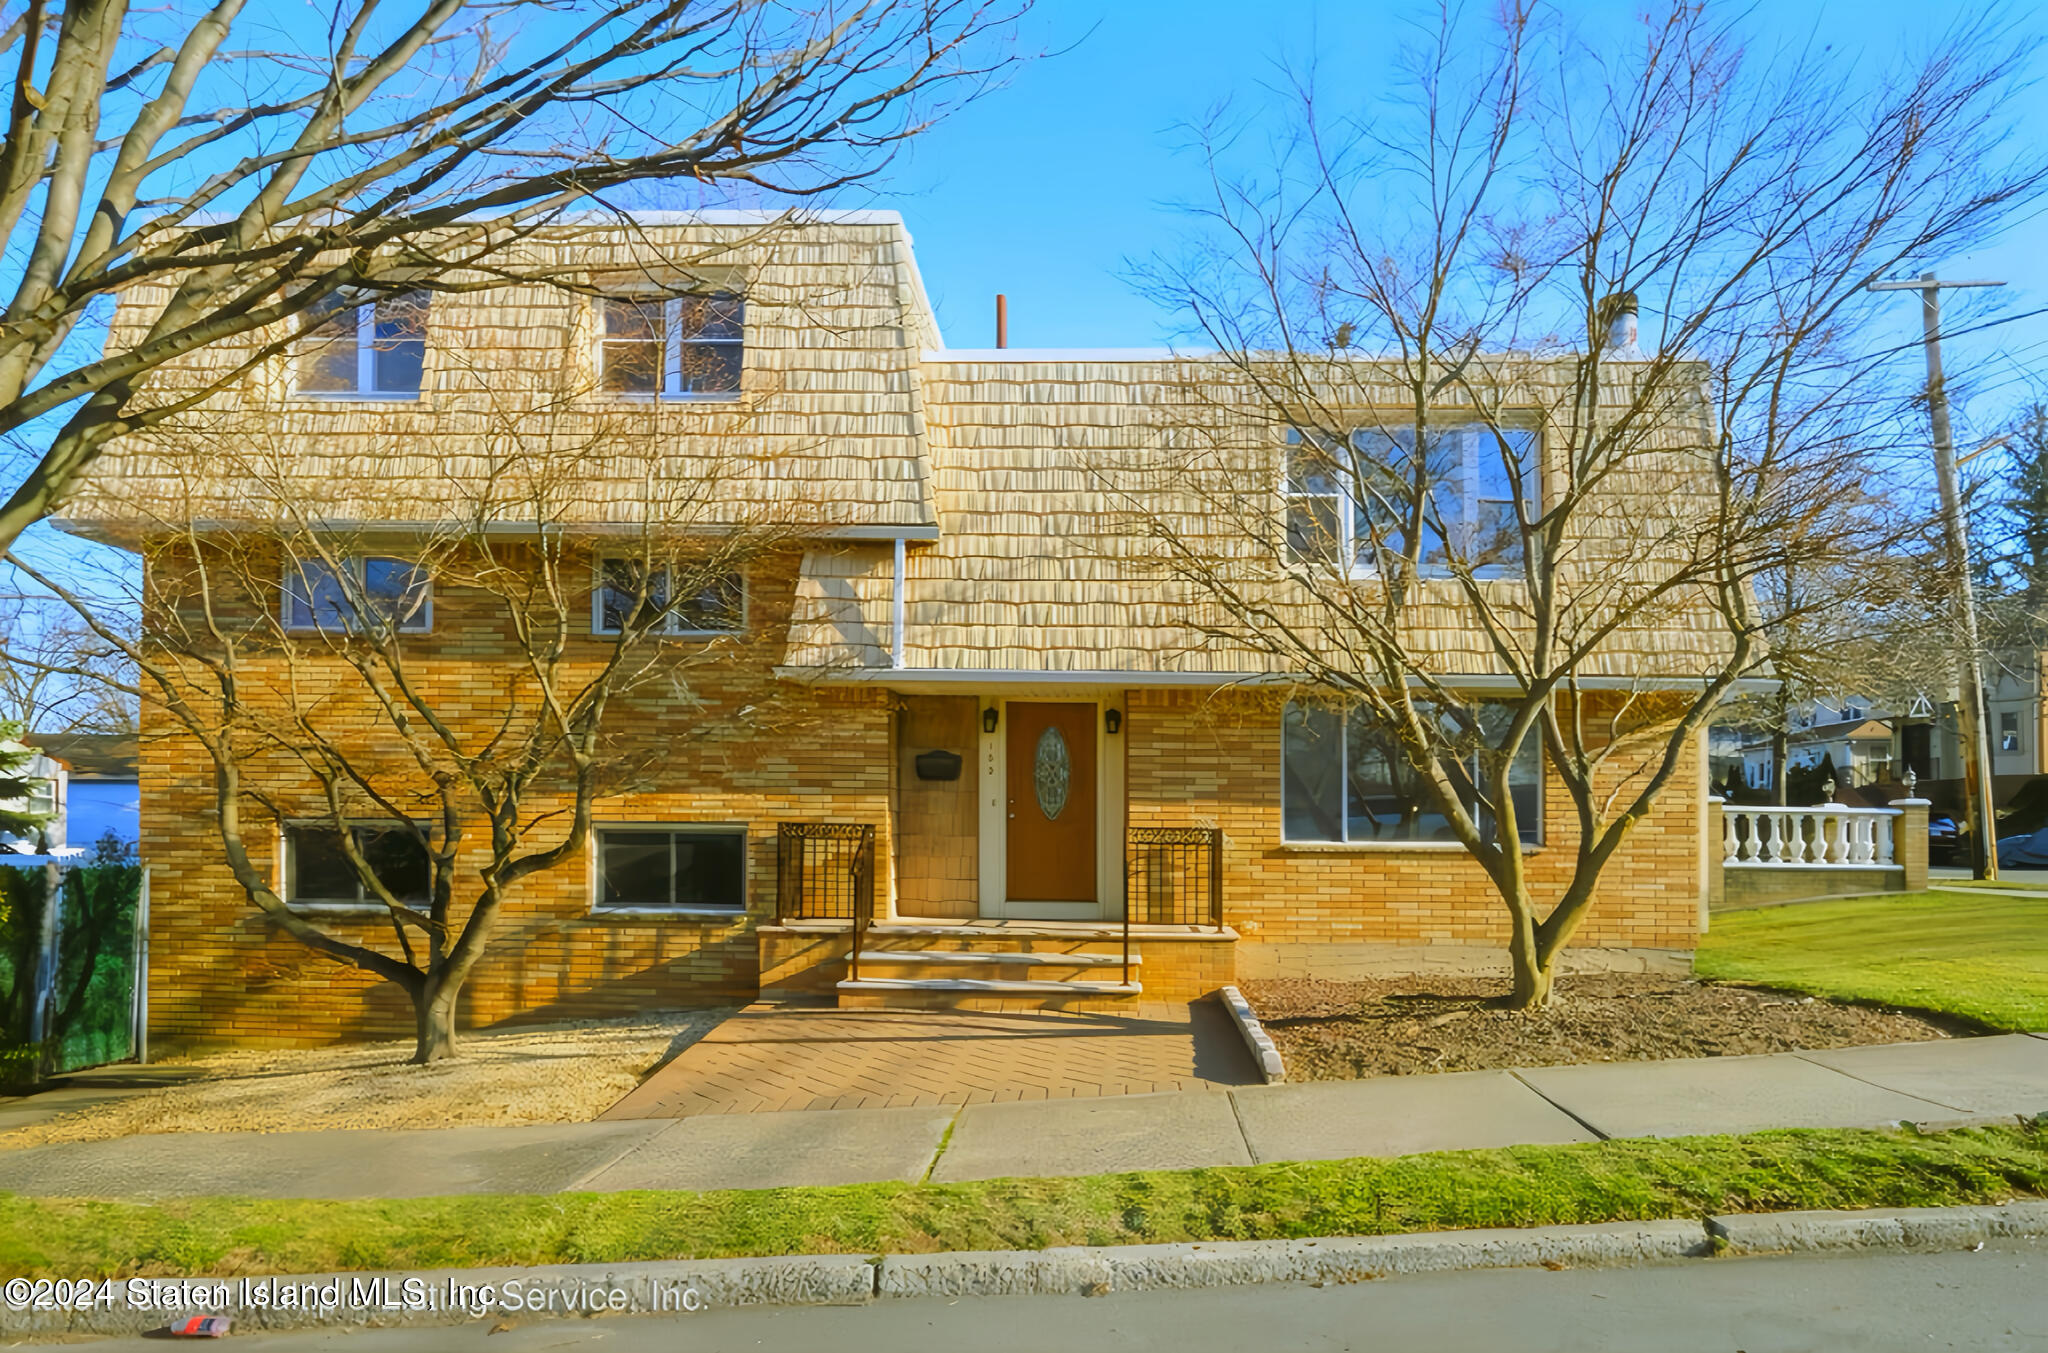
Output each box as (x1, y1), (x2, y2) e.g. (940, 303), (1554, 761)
(1284, 424), (1540, 577)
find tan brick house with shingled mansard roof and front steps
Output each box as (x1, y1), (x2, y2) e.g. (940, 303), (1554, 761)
(63, 213), (1712, 1046)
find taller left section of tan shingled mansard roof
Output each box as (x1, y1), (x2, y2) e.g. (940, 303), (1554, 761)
(63, 213), (940, 538)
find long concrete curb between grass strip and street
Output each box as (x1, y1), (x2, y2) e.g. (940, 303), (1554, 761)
(16, 1199), (2048, 1337)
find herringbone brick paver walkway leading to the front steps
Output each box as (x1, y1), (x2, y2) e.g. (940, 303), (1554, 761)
(604, 1001), (1260, 1120)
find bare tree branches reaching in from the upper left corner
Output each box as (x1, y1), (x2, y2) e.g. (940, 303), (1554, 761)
(0, 0), (1024, 551)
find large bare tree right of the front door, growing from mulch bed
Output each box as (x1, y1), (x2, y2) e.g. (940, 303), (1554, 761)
(1124, 4), (2044, 1009)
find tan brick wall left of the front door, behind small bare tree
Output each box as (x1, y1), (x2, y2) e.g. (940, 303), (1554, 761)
(141, 557), (893, 1046)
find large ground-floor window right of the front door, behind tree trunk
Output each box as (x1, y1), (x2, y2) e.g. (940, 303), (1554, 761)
(1280, 702), (1542, 845)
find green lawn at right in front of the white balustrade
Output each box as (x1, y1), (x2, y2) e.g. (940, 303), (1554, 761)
(1694, 892), (2048, 1030)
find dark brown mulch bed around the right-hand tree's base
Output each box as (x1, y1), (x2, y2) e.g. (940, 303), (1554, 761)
(1239, 974), (1976, 1081)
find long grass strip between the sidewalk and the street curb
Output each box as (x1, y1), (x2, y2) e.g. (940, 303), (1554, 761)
(0, 1126), (2048, 1277)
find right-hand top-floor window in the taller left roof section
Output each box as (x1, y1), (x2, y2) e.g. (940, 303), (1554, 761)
(598, 291), (745, 399)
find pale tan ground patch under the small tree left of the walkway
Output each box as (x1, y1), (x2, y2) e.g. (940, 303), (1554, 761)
(0, 1007), (733, 1150)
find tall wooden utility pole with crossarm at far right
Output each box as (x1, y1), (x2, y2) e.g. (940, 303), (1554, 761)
(1870, 272), (2005, 878)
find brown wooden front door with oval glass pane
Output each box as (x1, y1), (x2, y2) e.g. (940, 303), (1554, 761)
(1004, 700), (1096, 903)
